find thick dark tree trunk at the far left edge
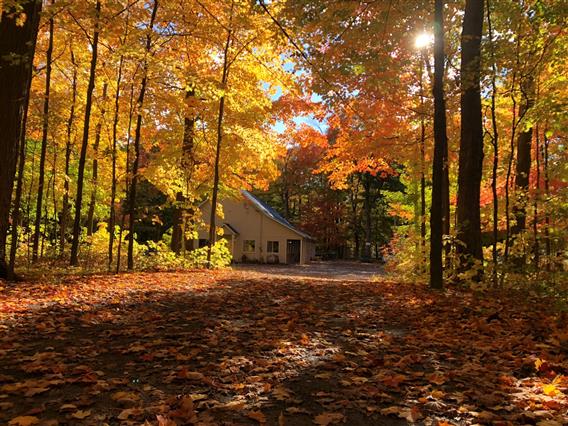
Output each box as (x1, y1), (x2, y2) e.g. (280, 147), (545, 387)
(0, 0), (42, 277)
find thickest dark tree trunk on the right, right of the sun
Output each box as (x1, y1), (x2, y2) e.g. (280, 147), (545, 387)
(457, 0), (484, 268)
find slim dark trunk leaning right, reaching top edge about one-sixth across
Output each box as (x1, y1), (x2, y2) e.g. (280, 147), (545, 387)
(70, 0), (101, 266)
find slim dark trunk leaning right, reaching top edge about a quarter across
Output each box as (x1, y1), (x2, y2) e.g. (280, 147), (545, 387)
(128, 0), (158, 270)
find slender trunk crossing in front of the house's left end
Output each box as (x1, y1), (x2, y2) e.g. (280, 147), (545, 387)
(207, 20), (233, 267)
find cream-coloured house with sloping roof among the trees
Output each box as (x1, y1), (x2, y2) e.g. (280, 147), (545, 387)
(194, 190), (315, 264)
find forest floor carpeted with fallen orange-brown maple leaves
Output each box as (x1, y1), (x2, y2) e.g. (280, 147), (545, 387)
(0, 268), (568, 426)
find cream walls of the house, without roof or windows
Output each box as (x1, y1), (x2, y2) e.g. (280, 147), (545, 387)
(198, 198), (315, 263)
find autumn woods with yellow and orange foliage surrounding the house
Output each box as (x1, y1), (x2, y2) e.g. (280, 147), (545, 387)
(0, 0), (566, 288)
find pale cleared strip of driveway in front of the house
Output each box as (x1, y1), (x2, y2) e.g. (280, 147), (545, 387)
(233, 261), (384, 281)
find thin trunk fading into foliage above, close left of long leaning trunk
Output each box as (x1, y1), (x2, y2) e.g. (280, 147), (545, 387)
(59, 46), (77, 256)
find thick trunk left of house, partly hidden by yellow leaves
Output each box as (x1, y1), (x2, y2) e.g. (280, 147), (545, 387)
(171, 89), (195, 254)
